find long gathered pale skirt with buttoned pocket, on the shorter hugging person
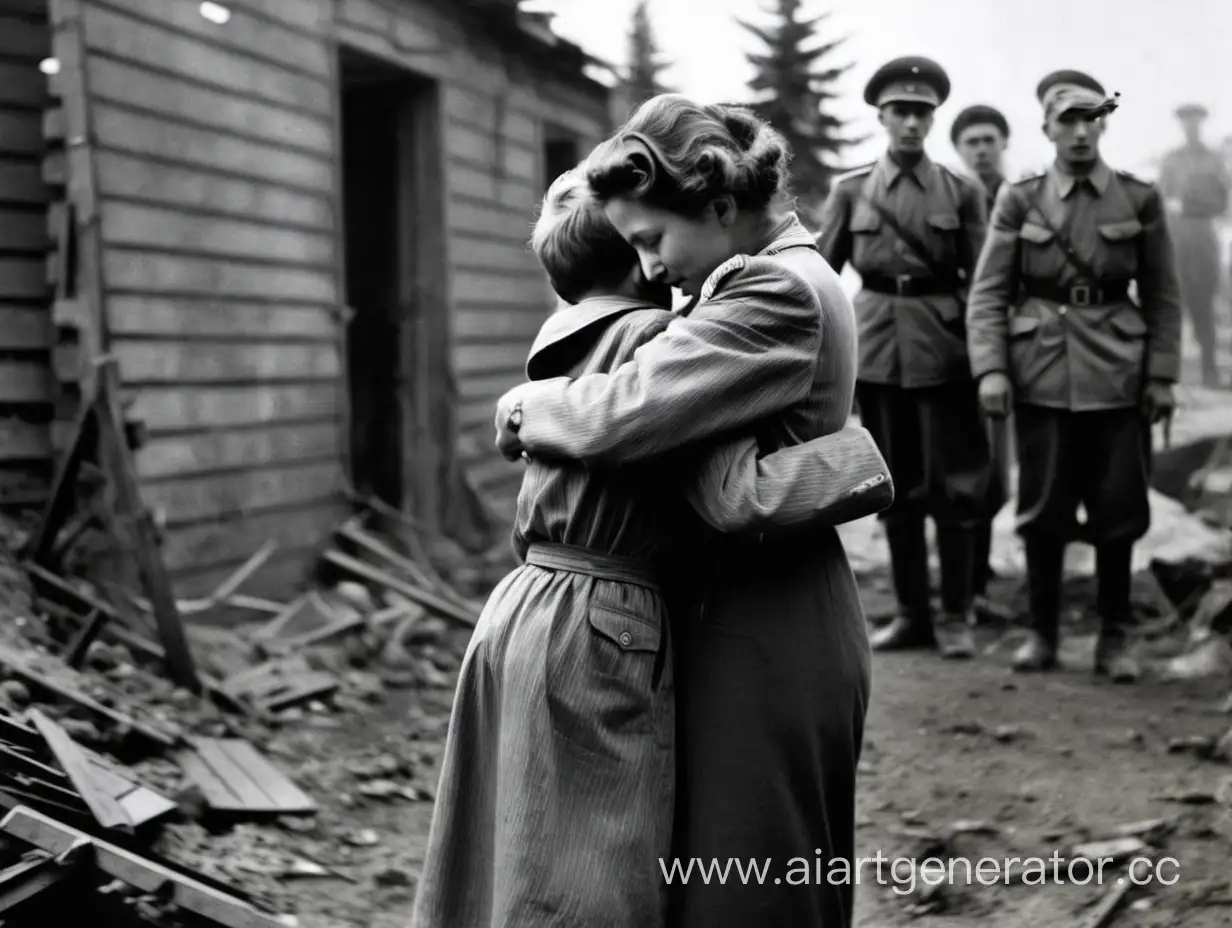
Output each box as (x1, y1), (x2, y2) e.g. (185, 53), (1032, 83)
(411, 545), (675, 928)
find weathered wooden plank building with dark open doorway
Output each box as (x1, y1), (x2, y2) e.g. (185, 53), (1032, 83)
(0, 0), (610, 596)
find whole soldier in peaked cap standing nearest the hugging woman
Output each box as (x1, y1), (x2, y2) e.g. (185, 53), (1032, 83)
(817, 57), (991, 658)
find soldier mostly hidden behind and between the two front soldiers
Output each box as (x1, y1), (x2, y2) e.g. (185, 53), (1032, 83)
(950, 104), (1013, 610)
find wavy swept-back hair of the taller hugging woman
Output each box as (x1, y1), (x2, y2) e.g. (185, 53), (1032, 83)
(586, 94), (791, 218)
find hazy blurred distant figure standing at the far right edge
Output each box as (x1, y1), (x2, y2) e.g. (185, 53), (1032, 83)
(1159, 104), (1230, 387)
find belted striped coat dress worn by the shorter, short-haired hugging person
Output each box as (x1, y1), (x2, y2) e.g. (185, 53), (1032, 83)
(413, 285), (891, 928)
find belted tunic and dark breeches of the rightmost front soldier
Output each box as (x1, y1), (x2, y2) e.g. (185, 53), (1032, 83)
(967, 163), (1180, 534)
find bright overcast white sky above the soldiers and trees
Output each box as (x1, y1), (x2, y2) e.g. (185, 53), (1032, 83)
(525, 0), (1232, 175)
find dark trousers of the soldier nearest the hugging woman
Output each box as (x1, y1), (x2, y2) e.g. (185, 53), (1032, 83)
(856, 380), (992, 620)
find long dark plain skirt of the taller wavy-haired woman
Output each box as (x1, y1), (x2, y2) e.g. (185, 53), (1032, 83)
(671, 527), (872, 928)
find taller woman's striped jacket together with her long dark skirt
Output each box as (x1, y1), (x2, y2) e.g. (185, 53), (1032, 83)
(505, 218), (872, 928)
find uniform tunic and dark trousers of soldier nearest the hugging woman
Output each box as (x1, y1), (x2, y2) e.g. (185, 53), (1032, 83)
(817, 154), (995, 527)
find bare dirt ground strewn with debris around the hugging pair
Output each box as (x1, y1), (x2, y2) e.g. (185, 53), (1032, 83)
(209, 564), (1232, 928)
